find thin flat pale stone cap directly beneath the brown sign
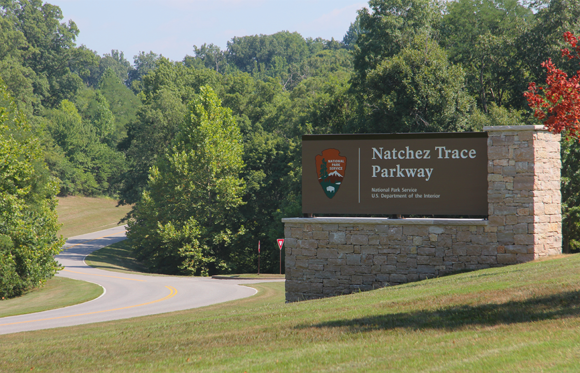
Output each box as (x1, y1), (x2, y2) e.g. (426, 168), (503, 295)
(282, 217), (488, 226)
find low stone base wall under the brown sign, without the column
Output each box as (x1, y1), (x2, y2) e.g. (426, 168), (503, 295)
(283, 218), (488, 301)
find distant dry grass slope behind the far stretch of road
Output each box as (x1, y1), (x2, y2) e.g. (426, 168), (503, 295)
(57, 196), (131, 237)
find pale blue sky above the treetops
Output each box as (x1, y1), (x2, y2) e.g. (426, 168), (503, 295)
(46, 0), (367, 61)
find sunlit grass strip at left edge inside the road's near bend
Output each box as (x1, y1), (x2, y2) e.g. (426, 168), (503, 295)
(0, 277), (103, 316)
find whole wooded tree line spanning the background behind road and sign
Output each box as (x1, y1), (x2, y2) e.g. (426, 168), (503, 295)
(0, 0), (580, 294)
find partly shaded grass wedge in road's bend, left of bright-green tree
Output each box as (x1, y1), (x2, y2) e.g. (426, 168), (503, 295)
(85, 240), (148, 273)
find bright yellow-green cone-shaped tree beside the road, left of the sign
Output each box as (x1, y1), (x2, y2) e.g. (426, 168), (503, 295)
(128, 87), (245, 275)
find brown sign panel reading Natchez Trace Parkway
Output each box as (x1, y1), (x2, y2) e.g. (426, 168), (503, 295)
(302, 132), (488, 216)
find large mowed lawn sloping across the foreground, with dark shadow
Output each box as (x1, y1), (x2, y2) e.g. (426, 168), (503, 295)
(0, 255), (580, 372)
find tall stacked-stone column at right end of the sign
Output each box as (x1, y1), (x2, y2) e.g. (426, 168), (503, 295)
(484, 126), (562, 265)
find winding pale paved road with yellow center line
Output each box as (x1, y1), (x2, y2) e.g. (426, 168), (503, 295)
(0, 227), (283, 334)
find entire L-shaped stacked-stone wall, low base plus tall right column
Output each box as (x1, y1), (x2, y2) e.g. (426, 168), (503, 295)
(283, 126), (562, 301)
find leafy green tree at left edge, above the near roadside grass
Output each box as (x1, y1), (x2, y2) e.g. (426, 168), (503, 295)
(0, 80), (64, 298)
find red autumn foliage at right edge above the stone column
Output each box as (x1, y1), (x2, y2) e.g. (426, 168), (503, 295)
(524, 32), (580, 138)
